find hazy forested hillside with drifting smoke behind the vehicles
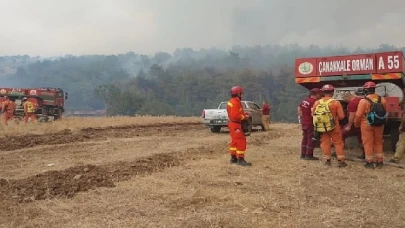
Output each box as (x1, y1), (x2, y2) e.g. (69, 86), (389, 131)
(0, 45), (405, 121)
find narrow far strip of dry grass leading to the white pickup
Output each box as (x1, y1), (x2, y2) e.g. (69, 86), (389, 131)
(0, 116), (201, 136)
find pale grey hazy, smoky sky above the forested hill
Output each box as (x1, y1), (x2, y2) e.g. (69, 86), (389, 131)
(0, 0), (405, 57)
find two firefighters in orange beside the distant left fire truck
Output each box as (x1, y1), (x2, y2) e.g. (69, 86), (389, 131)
(1, 96), (36, 125)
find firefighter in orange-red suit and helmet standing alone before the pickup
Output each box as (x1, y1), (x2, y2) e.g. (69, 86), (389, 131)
(226, 86), (252, 166)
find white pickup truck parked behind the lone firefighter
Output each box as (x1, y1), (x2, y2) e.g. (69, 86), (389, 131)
(202, 101), (264, 133)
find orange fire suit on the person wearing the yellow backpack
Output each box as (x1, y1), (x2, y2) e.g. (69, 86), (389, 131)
(312, 96), (345, 161)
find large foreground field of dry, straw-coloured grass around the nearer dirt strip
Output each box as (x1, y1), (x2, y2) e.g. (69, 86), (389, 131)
(0, 118), (405, 228)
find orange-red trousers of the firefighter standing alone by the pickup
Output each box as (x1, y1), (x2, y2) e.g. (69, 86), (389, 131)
(228, 121), (246, 158)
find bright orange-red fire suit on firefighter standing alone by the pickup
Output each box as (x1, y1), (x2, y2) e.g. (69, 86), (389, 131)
(226, 97), (246, 158)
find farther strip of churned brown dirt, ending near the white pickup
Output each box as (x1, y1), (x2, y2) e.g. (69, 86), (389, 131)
(0, 122), (203, 151)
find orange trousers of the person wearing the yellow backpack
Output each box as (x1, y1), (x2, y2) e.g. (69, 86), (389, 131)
(320, 126), (345, 161)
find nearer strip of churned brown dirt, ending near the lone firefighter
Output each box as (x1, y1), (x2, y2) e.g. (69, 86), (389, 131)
(0, 142), (227, 203)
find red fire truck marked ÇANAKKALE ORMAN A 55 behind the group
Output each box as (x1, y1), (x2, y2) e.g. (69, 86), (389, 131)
(295, 51), (405, 151)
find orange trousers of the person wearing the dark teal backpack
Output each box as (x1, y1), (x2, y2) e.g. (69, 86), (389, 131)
(360, 122), (384, 162)
